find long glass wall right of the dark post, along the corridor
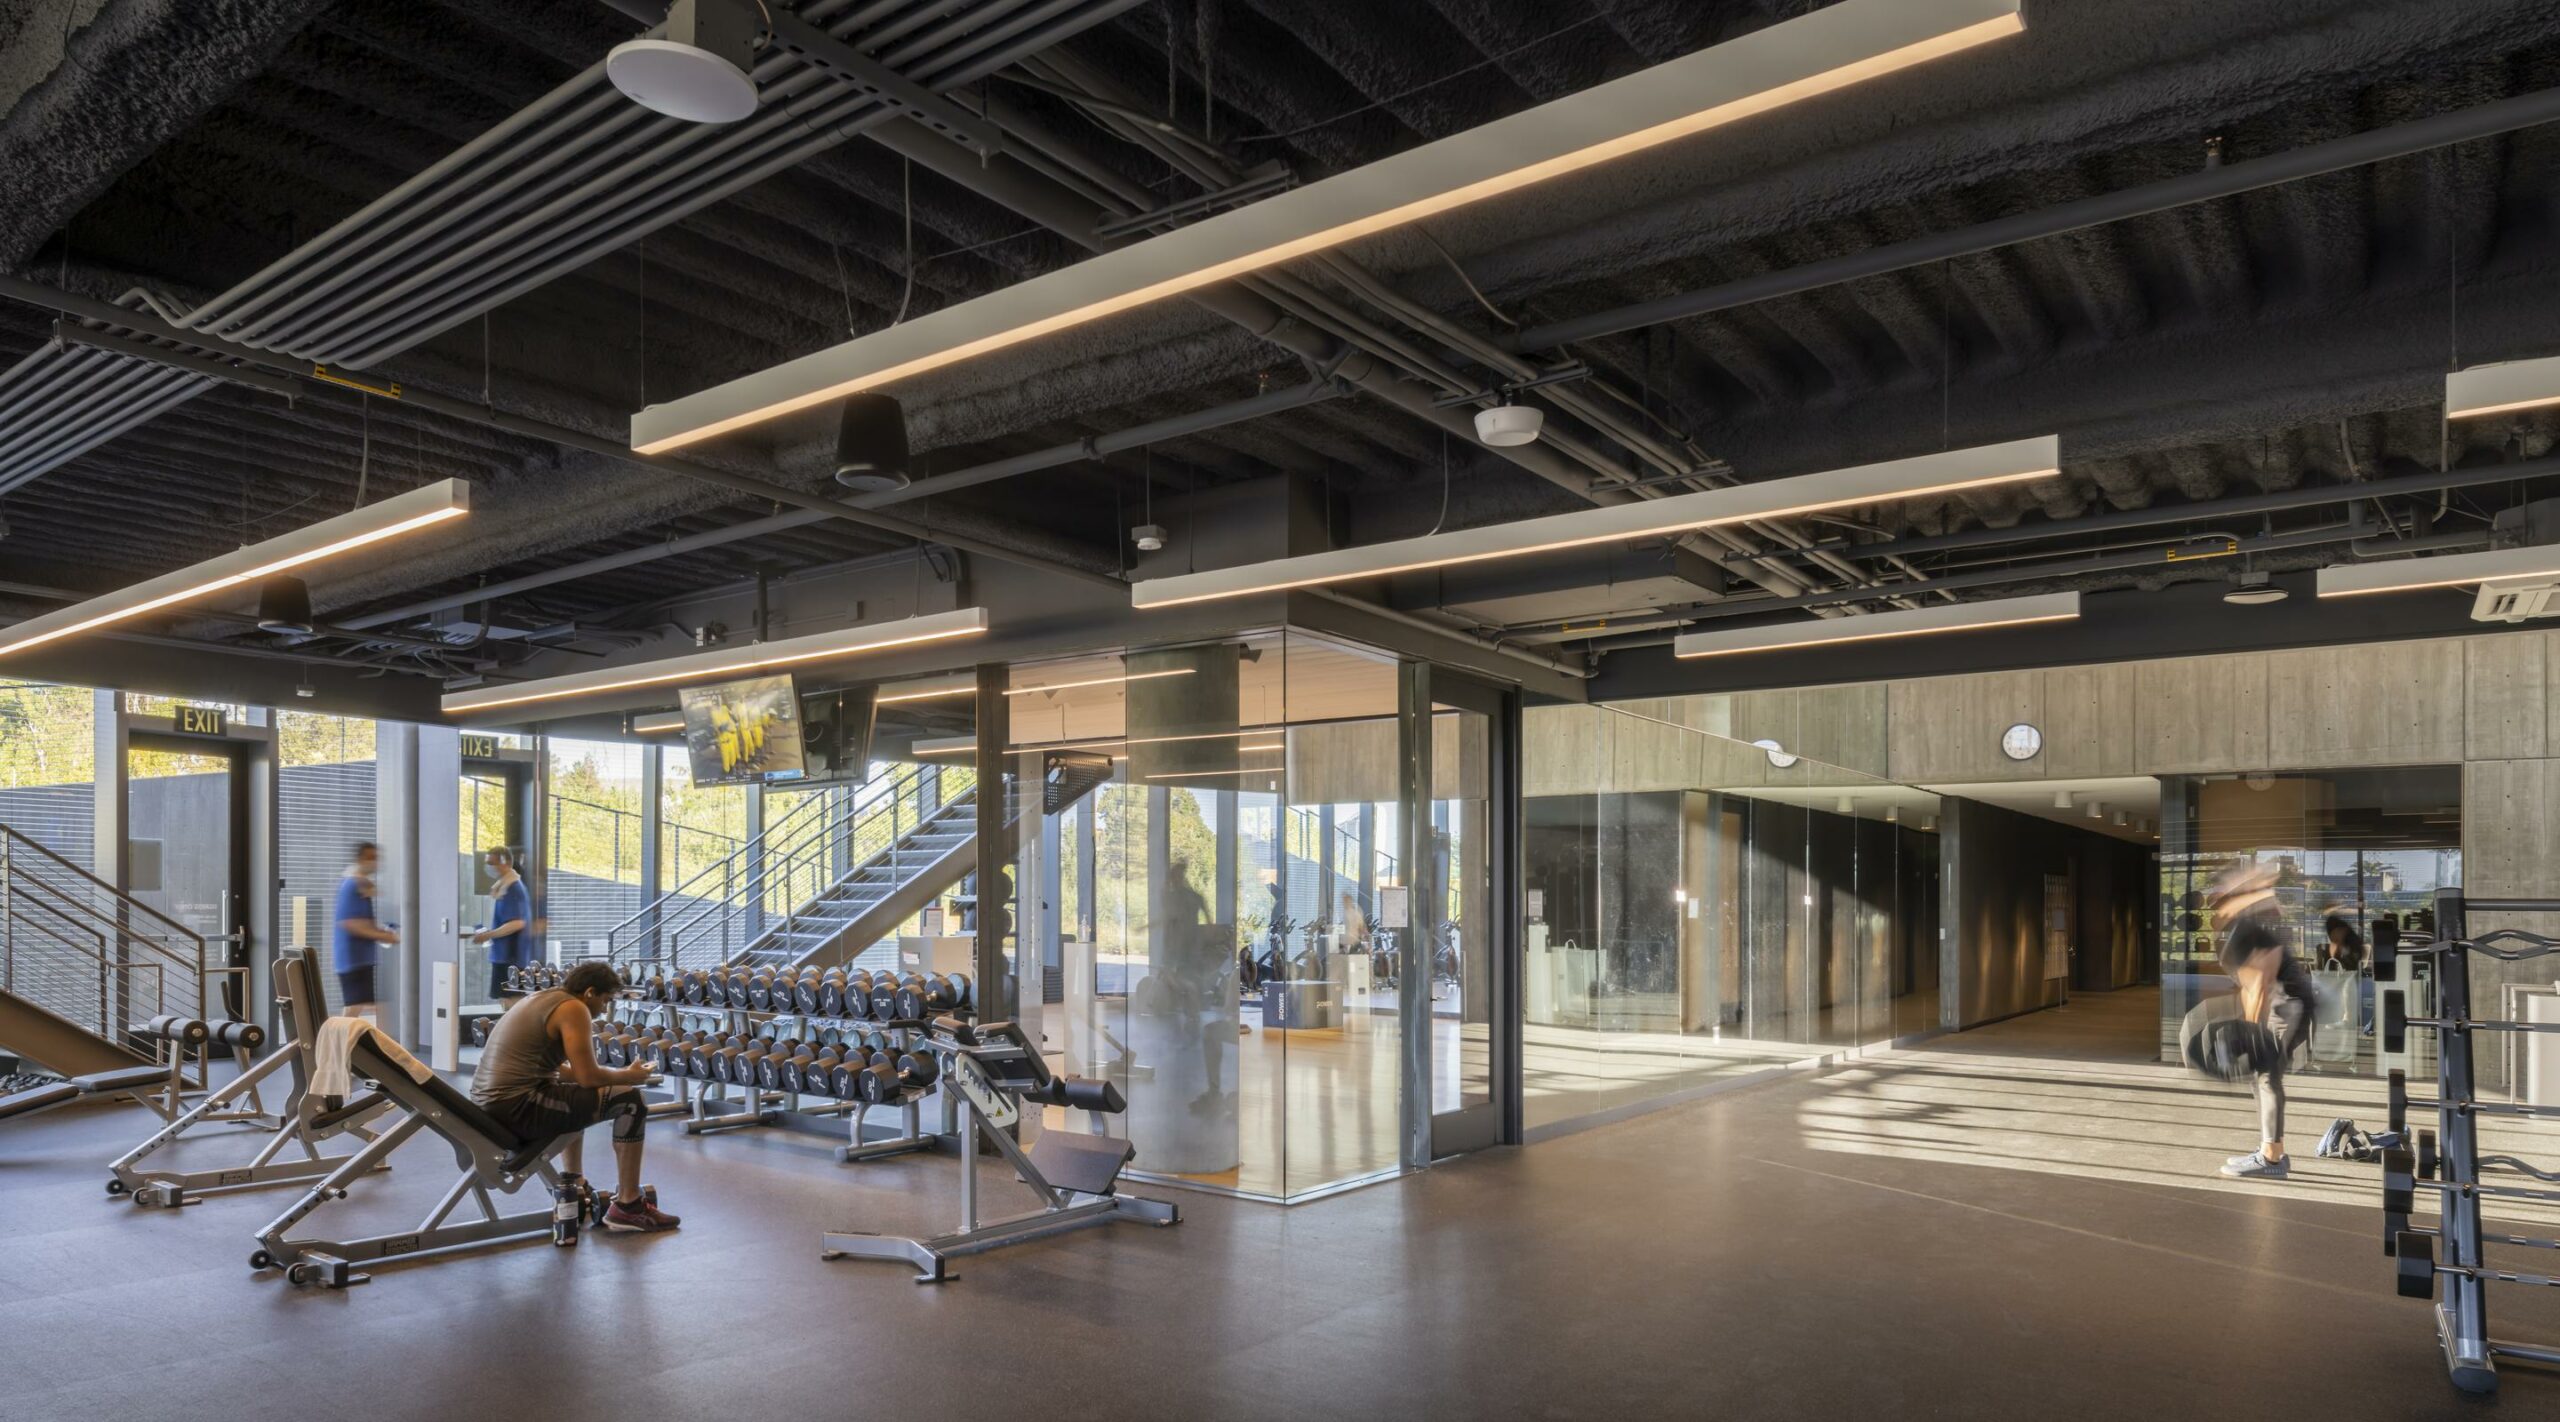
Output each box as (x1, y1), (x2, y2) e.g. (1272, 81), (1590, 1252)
(1521, 707), (1940, 1132)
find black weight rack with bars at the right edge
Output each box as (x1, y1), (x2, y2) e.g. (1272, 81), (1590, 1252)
(2373, 889), (2560, 1394)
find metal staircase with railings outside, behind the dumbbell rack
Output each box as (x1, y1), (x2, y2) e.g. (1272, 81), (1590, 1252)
(607, 766), (978, 976)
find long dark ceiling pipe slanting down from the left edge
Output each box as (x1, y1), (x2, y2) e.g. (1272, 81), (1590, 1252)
(0, 274), (1129, 592)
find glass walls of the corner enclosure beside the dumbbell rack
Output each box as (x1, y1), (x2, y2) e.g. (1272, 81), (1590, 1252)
(1006, 633), (1423, 1199)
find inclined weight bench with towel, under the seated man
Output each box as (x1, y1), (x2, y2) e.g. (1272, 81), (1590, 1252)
(248, 1035), (568, 1289)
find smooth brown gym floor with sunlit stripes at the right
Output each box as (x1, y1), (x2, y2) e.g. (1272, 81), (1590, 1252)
(0, 994), (2560, 1422)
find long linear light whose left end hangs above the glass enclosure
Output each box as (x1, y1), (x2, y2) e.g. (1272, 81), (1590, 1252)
(1129, 435), (2061, 607)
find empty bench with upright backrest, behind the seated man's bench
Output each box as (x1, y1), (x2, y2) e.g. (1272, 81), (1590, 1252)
(108, 948), (392, 1207)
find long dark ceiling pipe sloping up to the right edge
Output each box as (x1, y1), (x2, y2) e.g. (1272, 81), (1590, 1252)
(1503, 90), (2560, 351)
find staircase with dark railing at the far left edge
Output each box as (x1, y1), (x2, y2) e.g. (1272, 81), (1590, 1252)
(0, 825), (208, 1084)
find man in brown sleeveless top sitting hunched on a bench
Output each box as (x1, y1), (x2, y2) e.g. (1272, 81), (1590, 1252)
(471, 963), (678, 1232)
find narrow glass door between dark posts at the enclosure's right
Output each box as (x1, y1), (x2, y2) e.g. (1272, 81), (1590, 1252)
(1433, 669), (1518, 1156)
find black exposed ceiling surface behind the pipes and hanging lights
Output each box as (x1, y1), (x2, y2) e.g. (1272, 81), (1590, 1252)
(0, 0), (2560, 676)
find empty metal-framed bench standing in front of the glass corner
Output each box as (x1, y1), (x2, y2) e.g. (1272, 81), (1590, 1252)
(819, 1017), (1183, 1284)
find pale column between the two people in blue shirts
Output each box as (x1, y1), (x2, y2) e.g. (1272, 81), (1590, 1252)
(374, 720), (463, 1053)
